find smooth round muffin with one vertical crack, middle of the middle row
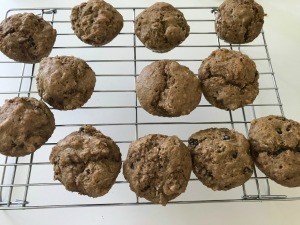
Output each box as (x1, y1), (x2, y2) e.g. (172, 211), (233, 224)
(136, 60), (201, 117)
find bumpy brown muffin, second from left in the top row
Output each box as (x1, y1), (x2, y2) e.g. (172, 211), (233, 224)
(71, 0), (123, 46)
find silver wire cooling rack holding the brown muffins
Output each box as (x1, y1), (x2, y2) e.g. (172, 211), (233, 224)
(0, 7), (300, 210)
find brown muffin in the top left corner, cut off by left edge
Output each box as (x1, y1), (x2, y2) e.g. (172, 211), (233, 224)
(0, 13), (56, 63)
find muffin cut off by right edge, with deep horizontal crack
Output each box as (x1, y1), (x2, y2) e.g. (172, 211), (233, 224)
(249, 115), (300, 187)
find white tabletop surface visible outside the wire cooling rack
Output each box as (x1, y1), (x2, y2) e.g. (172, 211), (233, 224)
(0, 0), (300, 225)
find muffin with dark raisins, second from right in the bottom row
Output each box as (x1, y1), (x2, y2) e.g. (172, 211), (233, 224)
(188, 128), (254, 191)
